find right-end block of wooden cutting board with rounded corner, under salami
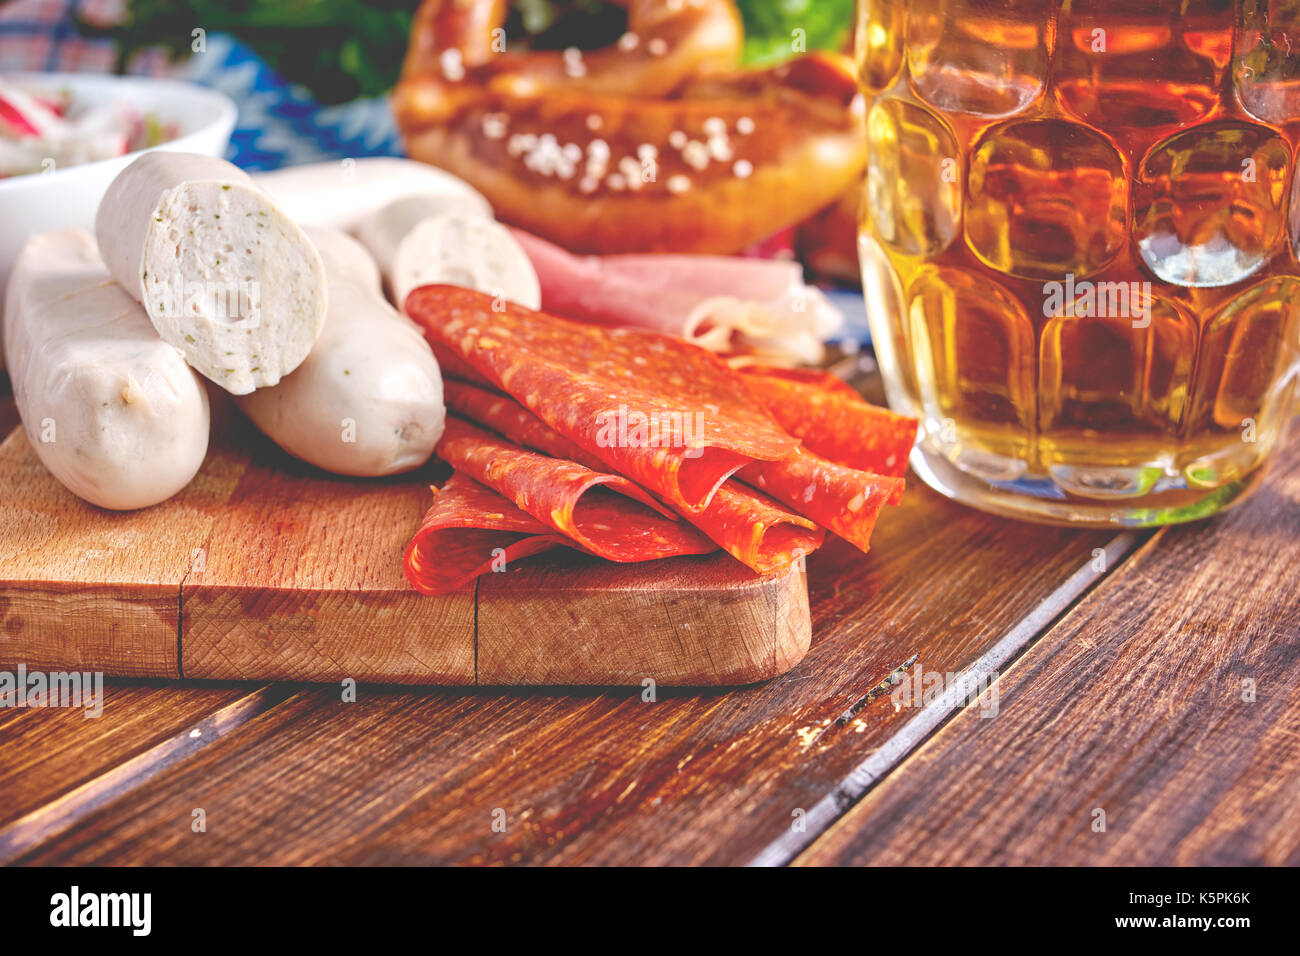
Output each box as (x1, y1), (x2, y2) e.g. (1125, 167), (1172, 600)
(478, 551), (813, 687)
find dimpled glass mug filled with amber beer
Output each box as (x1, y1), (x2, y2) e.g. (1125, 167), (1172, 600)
(857, 0), (1300, 525)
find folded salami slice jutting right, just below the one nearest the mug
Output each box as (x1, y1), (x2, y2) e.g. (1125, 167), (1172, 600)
(737, 450), (906, 551)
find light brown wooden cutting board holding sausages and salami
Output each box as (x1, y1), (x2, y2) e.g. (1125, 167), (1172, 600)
(0, 416), (811, 685)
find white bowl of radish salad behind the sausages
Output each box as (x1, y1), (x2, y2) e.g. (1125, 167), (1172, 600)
(0, 73), (235, 345)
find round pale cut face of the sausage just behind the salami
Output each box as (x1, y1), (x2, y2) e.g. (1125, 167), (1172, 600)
(366, 209), (542, 308)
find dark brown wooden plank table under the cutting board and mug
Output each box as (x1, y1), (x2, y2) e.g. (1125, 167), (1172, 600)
(0, 379), (1300, 865)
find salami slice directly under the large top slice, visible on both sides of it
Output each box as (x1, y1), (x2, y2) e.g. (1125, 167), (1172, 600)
(445, 378), (821, 574)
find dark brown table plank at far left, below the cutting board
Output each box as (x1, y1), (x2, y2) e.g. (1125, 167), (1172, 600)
(0, 682), (266, 839)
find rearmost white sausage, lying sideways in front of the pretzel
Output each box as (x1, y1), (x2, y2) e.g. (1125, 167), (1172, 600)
(254, 156), (491, 233)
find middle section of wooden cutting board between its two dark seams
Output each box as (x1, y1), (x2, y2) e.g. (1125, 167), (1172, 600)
(181, 419), (475, 684)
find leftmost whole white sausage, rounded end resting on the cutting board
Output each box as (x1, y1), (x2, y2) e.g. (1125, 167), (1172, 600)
(4, 229), (209, 510)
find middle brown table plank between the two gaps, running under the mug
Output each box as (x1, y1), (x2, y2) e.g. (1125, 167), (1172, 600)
(7, 483), (1128, 864)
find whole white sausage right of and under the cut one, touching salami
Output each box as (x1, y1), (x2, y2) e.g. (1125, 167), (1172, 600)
(235, 228), (447, 476)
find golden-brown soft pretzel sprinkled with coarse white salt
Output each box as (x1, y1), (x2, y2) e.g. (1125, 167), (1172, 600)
(394, 0), (866, 252)
